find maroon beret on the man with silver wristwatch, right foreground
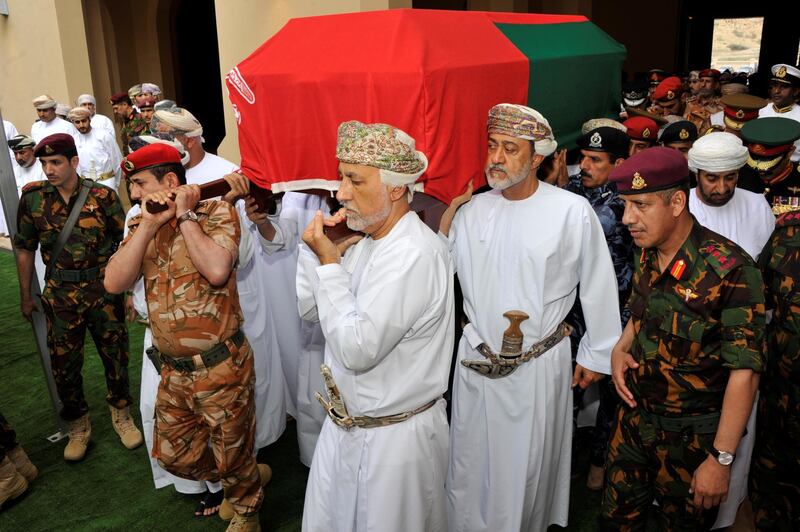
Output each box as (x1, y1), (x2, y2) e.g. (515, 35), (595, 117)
(608, 146), (689, 194)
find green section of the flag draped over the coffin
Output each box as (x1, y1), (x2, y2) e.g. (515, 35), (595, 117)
(497, 21), (626, 148)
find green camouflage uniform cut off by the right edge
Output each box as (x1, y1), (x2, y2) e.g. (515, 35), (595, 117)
(750, 213), (800, 531)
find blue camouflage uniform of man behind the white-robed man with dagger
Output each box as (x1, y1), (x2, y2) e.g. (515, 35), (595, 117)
(565, 174), (633, 467)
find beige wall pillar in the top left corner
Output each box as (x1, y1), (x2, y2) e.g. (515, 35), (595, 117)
(0, 0), (91, 134)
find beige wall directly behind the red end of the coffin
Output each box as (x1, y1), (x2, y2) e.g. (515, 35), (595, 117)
(214, 0), (411, 161)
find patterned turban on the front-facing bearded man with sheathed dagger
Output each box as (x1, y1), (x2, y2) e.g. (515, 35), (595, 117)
(486, 103), (558, 157)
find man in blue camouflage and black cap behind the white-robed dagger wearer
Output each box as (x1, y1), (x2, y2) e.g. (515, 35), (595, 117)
(565, 126), (633, 490)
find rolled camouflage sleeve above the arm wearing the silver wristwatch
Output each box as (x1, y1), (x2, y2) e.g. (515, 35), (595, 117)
(719, 264), (766, 372)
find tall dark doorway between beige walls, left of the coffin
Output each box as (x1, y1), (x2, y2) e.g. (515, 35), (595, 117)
(171, 0), (225, 153)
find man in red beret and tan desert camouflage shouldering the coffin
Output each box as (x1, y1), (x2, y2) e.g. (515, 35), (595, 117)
(105, 144), (269, 531)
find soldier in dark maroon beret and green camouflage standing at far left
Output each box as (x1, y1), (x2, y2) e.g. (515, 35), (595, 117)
(14, 133), (143, 460)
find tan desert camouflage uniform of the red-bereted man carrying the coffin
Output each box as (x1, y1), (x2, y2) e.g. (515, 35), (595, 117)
(122, 201), (263, 514)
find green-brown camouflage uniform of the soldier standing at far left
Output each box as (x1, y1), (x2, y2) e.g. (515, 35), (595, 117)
(14, 181), (132, 421)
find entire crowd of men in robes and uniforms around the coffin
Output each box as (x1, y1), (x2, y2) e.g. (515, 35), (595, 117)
(0, 59), (800, 532)
